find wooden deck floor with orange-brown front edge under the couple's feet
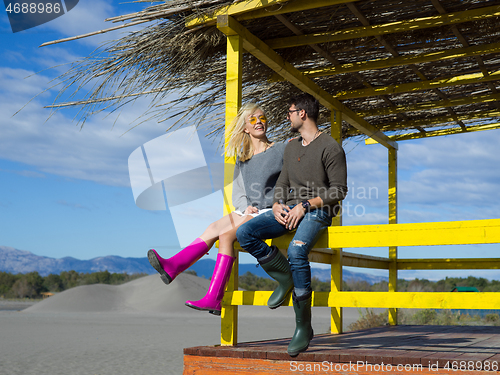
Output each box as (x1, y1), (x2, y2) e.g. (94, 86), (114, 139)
(184, 326), (500, 375)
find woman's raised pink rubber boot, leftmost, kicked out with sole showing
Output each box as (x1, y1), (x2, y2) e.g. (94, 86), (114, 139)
(148, 238), (208, 285)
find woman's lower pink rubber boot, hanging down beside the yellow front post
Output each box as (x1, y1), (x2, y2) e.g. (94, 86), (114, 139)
(186, 254), (236, 315)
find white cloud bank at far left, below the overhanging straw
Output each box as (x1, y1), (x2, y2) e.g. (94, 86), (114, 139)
(0, 68), (200, 186)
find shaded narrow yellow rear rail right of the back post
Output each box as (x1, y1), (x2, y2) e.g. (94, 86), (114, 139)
(398, 258), (500, 270)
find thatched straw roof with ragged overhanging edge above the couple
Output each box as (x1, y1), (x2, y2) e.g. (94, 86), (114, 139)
(45, 0), (500, 145)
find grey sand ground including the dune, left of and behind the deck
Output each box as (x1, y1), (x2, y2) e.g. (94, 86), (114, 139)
(0, 274), (368, 375)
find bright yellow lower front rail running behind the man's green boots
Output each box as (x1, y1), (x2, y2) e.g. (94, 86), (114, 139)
(223, 291), (500, 309)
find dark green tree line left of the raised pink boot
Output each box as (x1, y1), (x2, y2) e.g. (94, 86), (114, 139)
(0, 271), (146, 298)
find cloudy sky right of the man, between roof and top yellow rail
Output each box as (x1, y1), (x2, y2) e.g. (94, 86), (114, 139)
(345, 130), (500, 224)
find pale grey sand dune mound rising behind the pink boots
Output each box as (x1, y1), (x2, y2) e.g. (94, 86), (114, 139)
(23, 274), (209, 313)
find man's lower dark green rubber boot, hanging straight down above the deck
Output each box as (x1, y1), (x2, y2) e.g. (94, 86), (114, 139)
(288, 292), (314, 357)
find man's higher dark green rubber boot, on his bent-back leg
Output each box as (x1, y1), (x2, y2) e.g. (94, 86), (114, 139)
(259, 246), (293, 309)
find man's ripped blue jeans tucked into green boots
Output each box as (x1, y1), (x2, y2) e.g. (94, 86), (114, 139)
(236, 206), (332, 296)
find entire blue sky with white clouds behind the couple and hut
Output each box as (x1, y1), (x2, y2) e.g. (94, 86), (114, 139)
(0, 0), (500, 279)
